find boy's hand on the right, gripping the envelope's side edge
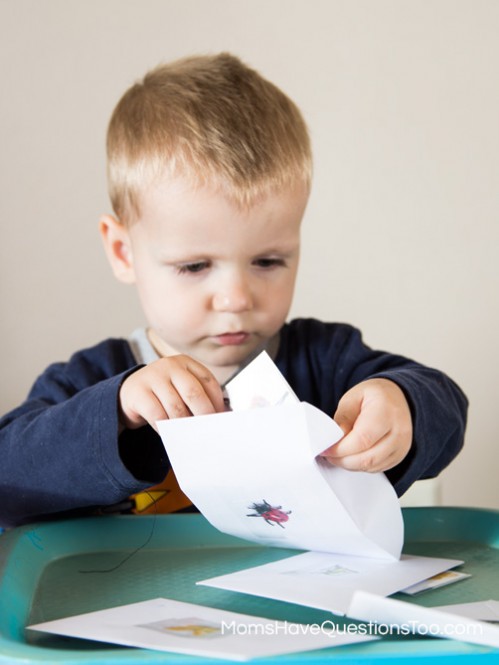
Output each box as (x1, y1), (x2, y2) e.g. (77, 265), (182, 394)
(322, 379), (412, 472)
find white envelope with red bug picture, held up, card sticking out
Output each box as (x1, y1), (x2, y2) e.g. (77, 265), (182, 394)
(158, 354), (403, 560)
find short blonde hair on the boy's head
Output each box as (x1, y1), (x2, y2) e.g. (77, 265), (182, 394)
(107, 53), (312, 221)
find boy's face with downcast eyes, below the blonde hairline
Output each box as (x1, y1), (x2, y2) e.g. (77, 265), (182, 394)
(104, 179), (307, 382)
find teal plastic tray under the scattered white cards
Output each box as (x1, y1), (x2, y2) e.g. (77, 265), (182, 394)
(0, 508), (499, 665)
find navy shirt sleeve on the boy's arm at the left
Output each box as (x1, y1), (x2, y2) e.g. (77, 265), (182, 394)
(0, 345), (166, 526)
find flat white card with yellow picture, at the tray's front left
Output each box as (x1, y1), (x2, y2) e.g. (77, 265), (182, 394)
(28, 598), (373, 661)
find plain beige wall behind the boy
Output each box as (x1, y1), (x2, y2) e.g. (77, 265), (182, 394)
(0, 0), (499, 508)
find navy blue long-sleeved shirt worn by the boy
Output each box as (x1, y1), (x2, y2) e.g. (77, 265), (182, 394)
(0, 319), (467, 526)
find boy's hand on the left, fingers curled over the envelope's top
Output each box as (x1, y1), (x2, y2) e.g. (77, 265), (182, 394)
(119, 355), (224, 429)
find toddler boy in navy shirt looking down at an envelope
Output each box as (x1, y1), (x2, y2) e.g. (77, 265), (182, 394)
(0, 54), (467, 526)
